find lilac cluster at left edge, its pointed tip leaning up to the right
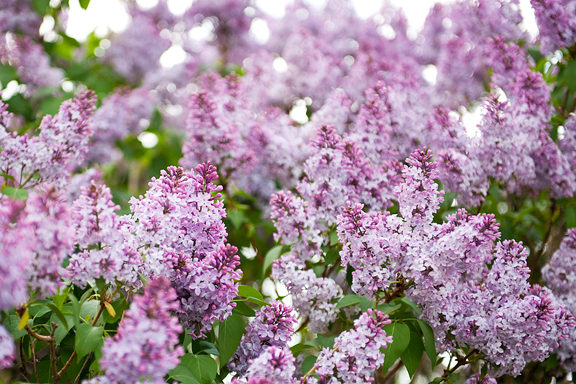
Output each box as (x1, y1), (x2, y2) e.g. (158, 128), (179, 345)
(0, 91), (96, 188)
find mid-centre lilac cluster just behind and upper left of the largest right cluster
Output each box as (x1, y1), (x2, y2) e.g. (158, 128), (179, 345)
(271, 125), (398, 258)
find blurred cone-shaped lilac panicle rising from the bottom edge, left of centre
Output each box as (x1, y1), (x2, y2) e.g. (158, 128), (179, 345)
(96, 277), (184, 383)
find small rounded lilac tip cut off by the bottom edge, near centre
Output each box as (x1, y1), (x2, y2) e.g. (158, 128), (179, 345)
(246, 346), (298, 384)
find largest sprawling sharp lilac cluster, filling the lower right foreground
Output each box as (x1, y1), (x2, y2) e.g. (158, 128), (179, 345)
(338, 150), (575, 376)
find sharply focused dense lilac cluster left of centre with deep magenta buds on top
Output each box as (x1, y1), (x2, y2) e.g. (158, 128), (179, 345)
(130, 163), (241, 337)
